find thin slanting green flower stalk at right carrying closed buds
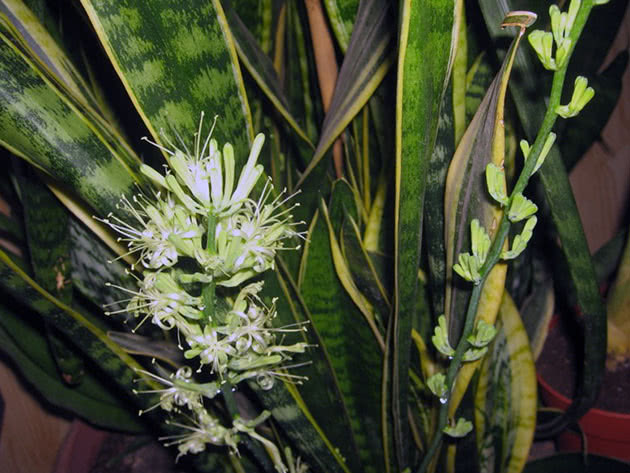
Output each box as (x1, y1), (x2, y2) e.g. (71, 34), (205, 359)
(417, 4), (593, 473)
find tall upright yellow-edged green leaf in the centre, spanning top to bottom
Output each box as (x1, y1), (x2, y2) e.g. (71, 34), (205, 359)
(390, 0), (455, 464)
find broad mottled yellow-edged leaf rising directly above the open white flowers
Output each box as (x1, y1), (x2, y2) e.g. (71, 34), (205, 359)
(81, 0), (253, 160)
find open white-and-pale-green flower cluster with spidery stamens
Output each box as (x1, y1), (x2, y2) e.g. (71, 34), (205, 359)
(95, 114), (308, 471)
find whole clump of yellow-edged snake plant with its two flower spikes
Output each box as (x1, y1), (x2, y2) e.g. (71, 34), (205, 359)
(0, 0), (621, 473)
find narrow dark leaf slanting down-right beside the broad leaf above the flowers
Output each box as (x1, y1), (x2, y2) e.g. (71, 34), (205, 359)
(226, 6), (315, 148)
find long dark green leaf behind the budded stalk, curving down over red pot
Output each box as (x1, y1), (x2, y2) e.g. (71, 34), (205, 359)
(480, 0), (606, 435)
